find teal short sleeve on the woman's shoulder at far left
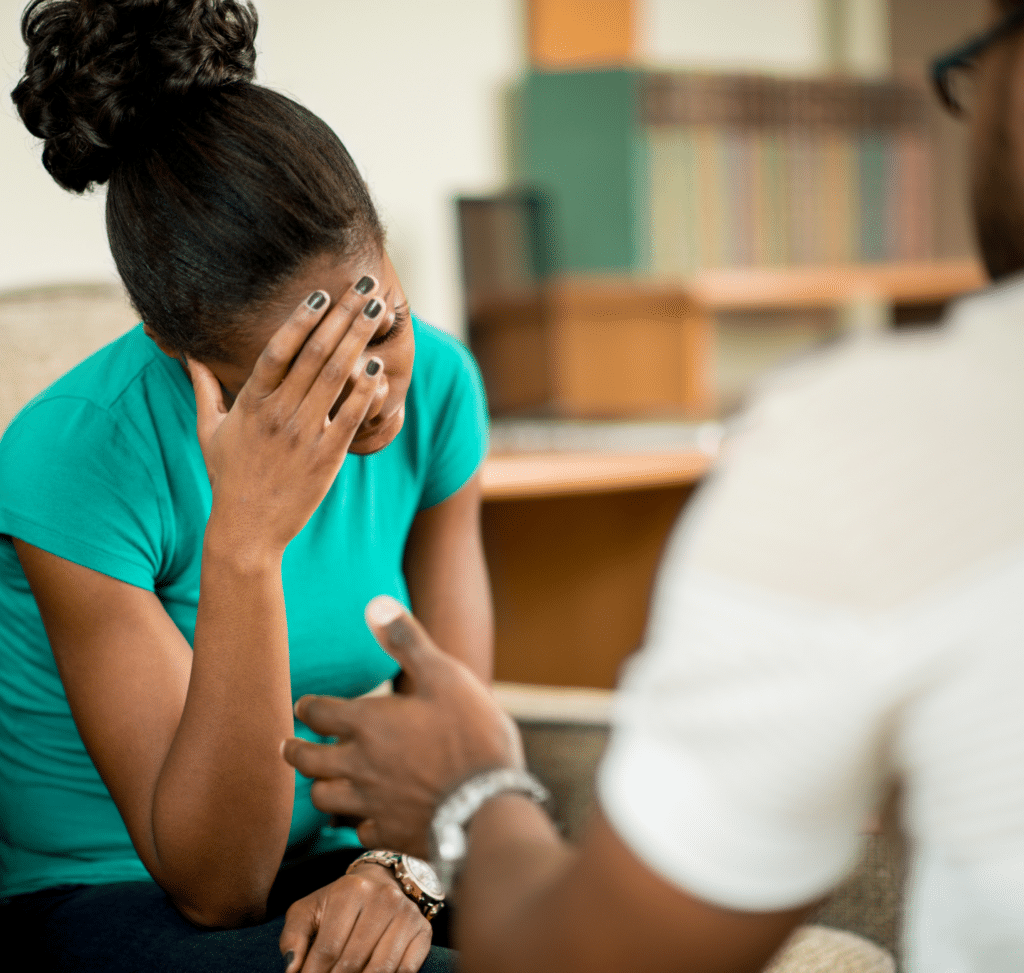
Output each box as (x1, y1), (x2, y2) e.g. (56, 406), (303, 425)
(0, 396), (165, 591)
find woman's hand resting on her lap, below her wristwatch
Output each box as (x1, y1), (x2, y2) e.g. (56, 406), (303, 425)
(281, 862), (431, 973)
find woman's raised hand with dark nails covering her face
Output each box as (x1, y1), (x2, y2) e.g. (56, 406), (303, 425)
(187, 279), (384, 557)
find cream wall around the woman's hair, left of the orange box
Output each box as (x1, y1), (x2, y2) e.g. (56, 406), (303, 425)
(0, 0), (525, 331)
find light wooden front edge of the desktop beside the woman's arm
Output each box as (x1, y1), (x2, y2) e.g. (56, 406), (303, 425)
(482, 450), (712, 500)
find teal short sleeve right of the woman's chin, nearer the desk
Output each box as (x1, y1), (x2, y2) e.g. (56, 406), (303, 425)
(415, 323), (487, 510)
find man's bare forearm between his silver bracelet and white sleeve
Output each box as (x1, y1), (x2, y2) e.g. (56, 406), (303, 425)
(457, 795), (811, 973)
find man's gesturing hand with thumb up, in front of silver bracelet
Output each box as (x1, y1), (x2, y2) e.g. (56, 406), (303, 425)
(282, 595), (523, 857)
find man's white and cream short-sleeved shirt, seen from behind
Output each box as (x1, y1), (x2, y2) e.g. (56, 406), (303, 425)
(599, 282), (1024, 973)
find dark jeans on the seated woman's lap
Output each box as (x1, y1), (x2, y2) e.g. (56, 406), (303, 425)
(0, 849), (456, 973)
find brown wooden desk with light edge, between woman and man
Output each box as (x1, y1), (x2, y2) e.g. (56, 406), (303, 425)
(483, 451), (712, 688)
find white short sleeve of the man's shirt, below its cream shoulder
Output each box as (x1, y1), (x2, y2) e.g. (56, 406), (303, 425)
(598, 456), (902, 912)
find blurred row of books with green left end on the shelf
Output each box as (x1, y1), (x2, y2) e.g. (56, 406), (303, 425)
(517, 68), (934, 277)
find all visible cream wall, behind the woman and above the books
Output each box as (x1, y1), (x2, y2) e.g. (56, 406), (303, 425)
(0, 0), (921, 332)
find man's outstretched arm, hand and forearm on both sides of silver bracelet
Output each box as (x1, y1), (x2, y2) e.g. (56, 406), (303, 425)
(284, 598), (810, 973)
